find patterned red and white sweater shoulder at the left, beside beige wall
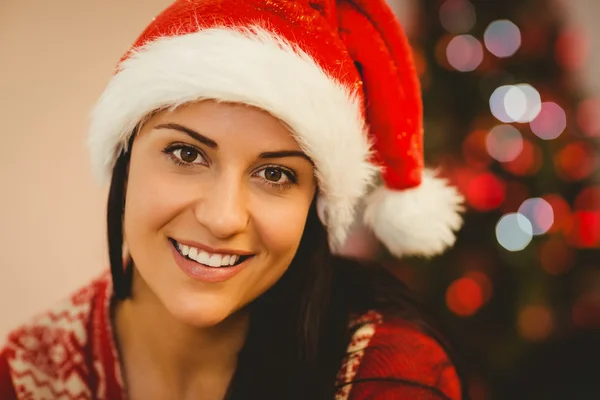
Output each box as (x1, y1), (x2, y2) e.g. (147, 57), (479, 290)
(0, 275), (109, 398)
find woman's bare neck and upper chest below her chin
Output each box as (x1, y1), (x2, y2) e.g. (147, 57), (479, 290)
(115, 272), (249, 398)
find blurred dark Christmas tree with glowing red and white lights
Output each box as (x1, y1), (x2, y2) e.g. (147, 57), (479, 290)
(390, 0), (600, 399)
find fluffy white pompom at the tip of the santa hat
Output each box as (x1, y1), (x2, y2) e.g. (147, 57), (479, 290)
(364, 170), (463, 257)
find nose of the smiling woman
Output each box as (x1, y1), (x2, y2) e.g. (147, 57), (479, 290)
(194, 175), (250, 239)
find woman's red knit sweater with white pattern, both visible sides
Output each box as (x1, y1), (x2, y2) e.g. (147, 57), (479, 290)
(0, 276), (460, 400)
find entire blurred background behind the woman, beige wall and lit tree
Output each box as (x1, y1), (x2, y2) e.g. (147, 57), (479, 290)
(0, 0), (600, 400)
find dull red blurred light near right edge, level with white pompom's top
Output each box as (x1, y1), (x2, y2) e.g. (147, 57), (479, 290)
(554, 142), (598, 181)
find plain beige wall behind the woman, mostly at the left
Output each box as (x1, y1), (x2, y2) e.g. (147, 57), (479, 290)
(0, 0), (600, 337)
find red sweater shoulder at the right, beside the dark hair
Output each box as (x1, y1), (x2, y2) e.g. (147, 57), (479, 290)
(336, 311), (461, 400)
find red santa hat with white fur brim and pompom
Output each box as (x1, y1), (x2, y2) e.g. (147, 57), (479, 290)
(89, 0), (462, 256)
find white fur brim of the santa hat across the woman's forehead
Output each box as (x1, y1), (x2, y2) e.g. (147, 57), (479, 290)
(89, 27), (377, 248)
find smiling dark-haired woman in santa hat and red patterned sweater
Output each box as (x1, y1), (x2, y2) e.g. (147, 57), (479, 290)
(0, 0), (464, 400)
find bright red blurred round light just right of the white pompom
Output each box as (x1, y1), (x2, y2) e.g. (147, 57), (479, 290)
(465, 172), (506, 211)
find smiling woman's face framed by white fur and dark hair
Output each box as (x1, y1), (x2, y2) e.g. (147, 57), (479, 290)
(124, 101), (316, 327)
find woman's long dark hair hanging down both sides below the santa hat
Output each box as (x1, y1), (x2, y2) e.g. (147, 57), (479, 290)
(107, 147), (466, 400)
